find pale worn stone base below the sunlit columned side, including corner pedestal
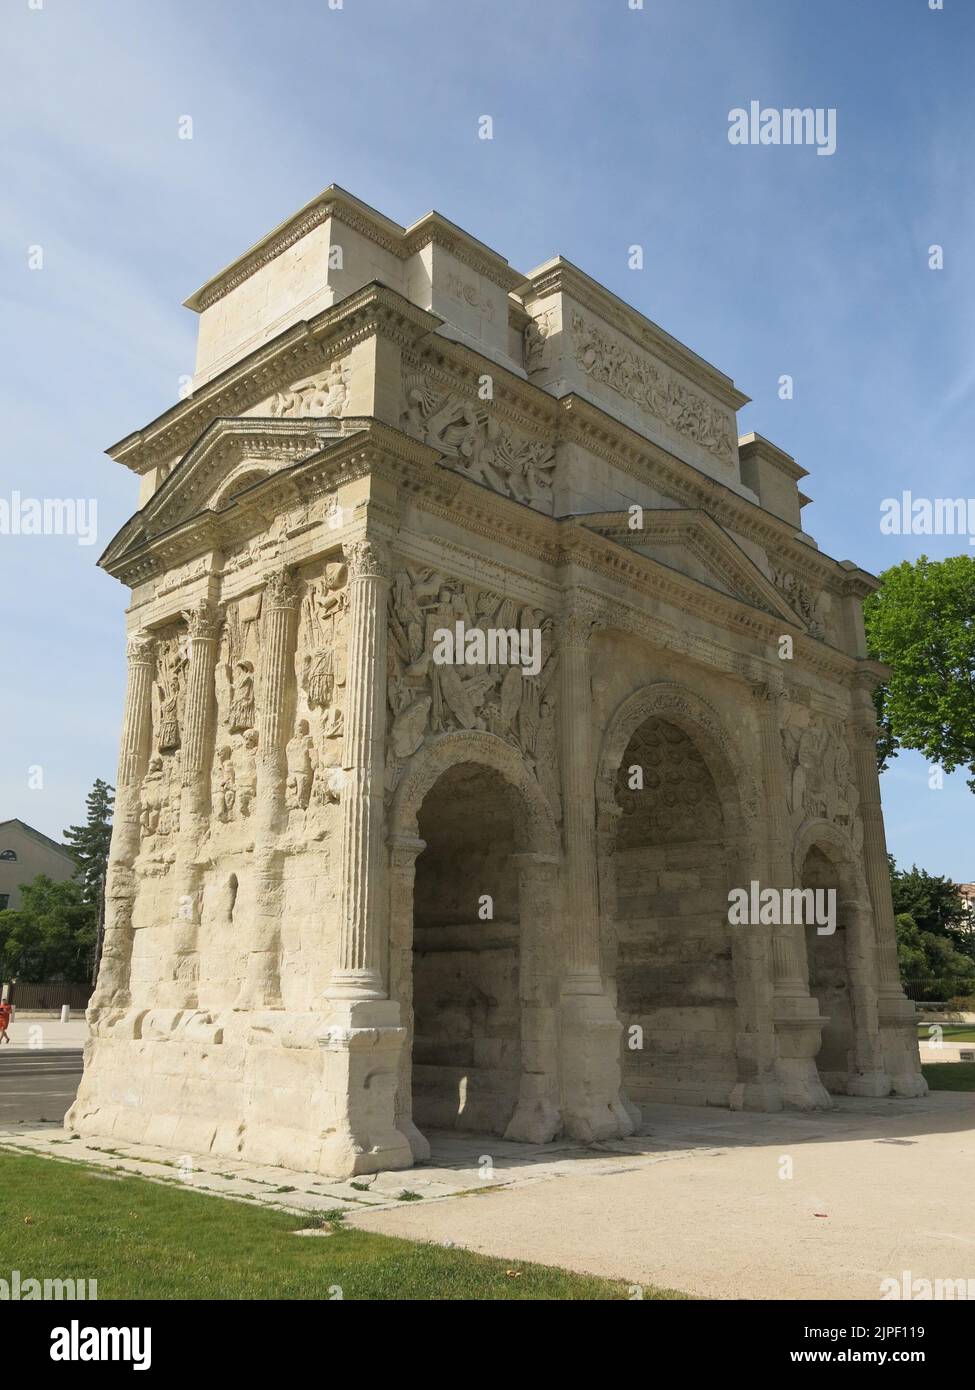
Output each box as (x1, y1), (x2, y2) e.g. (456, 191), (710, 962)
(65, 1005), (413, 1177)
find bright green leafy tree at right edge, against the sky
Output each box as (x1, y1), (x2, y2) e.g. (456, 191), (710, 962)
(864, 555), (975, 791)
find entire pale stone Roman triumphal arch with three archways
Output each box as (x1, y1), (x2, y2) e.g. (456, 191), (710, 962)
(68, 188), (925, 1175)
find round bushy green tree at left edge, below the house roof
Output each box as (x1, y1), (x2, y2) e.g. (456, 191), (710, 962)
(0, 874), (97, 981)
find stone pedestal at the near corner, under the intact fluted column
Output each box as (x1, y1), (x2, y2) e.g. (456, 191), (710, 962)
(319, 999), (411, 1177)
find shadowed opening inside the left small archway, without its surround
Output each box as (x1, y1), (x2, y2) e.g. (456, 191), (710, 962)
(413, 763), (522, 1134)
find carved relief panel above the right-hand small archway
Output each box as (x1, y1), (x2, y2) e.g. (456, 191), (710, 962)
(782, 706), (864, 853)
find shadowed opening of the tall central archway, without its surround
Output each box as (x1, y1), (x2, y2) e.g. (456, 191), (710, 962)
(615, 716), (737, 1105)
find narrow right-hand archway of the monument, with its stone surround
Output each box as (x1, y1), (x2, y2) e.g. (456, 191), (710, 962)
(793, 820), (890, 1097)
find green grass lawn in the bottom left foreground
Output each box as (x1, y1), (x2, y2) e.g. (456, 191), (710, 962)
(0, 1145), (684, 1300)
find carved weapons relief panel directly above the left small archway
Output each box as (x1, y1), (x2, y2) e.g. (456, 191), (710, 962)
(387, 569), (561, 816)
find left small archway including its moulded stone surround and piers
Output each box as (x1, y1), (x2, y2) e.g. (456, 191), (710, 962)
(388, 731), (561, 1158)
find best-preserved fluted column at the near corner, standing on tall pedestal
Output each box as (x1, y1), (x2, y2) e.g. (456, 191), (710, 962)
(327, 539), (389, 999)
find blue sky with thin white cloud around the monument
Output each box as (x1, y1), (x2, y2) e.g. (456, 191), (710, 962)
(0, 0), (975, 878)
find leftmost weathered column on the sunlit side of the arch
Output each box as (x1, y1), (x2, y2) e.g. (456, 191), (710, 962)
(89, 632), (156, 1013)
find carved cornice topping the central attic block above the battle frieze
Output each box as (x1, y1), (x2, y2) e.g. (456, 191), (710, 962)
(515, 256), (751, 410)
